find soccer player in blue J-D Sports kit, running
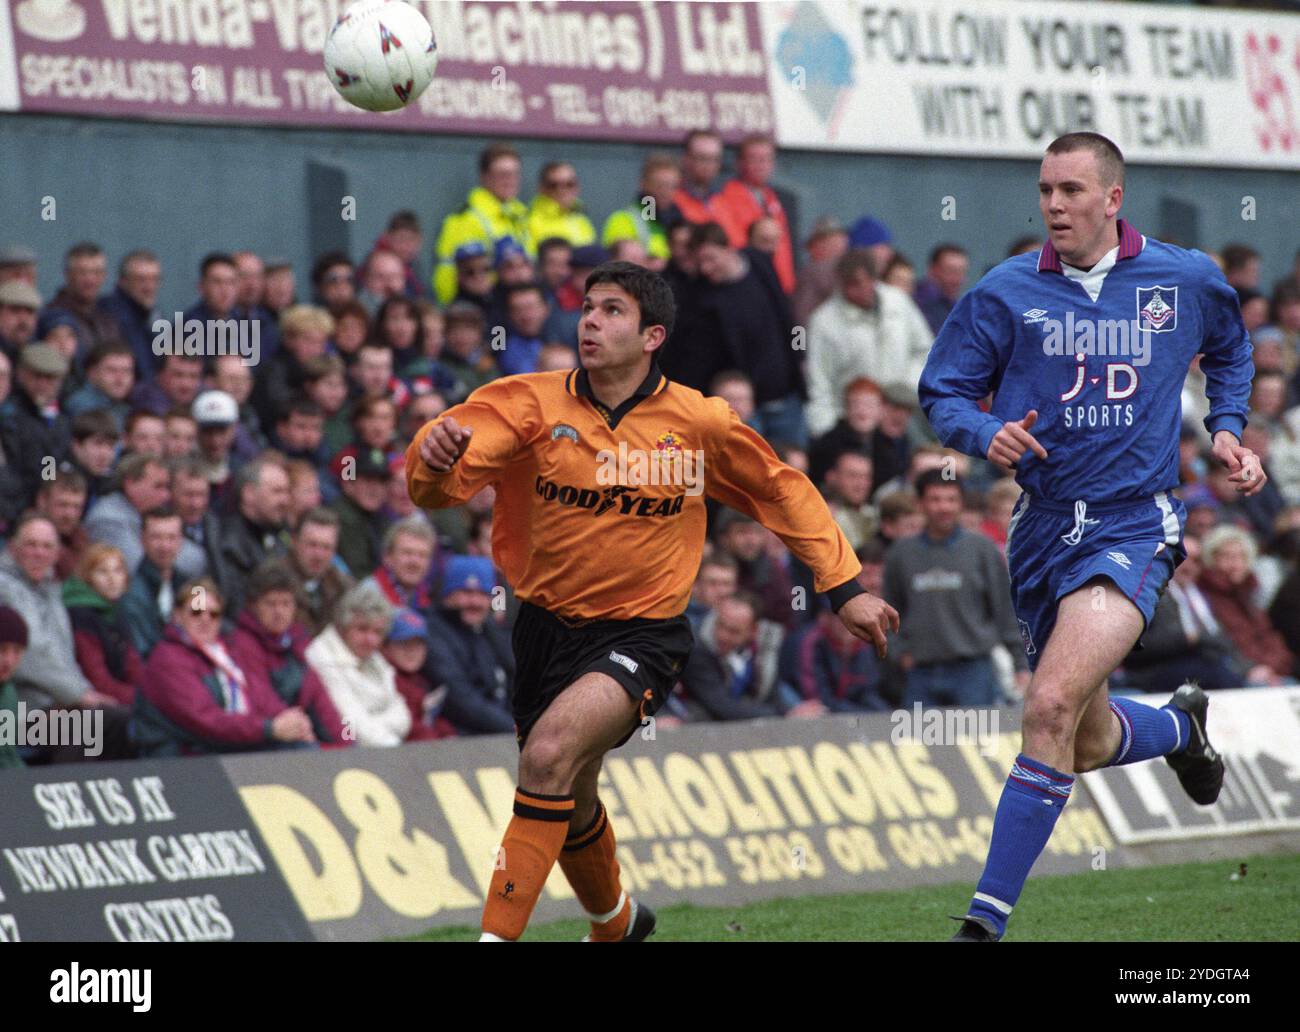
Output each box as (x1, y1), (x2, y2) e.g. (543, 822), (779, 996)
(920, 133), (1265, 942)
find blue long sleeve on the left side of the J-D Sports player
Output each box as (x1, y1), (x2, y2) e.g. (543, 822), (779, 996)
(919, 287), (1013, 459)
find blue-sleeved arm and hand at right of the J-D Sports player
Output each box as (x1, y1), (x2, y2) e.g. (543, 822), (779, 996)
(1199, 259), (1269, 495)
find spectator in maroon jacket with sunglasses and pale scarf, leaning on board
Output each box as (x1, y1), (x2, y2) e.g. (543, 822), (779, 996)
(133, 577), (316, 756)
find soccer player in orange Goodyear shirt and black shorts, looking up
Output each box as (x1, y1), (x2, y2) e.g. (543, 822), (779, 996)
(407, 261), (898, 942)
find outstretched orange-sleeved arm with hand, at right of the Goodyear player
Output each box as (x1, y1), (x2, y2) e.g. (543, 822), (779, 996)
(705, 399), (898, 656)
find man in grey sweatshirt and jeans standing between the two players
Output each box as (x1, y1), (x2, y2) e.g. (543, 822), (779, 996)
(884, 469), (1028, 708)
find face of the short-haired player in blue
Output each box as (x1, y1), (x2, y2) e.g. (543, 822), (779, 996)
(1039, 151), (1125, 266)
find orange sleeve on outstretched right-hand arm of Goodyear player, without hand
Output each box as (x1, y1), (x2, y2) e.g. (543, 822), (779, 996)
(705, 402), (862, 591)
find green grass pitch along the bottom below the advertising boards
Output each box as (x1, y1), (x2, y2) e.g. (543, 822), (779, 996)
(417, 855), (1300, 942)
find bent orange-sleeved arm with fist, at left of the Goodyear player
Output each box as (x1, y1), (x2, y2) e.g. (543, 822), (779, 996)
(406, 377), (538, 508)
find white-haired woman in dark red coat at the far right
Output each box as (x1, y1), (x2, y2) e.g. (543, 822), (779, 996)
(1196, 525), (1295, 684)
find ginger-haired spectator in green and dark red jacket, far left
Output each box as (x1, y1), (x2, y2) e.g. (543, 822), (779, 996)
(64, 545), (144, 706)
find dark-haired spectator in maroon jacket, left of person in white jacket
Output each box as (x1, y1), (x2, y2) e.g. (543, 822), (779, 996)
(226, 560), (351, 745)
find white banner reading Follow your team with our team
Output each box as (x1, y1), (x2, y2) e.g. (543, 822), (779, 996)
(762, 0), (1300, 169)
